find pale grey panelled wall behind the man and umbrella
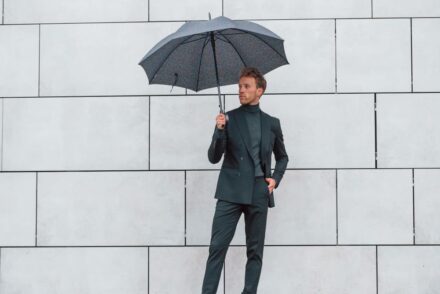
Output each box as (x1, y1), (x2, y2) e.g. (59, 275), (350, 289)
(0, 0), (440, 294)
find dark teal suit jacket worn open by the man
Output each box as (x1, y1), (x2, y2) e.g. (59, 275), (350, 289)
(208, 108), (289, 207)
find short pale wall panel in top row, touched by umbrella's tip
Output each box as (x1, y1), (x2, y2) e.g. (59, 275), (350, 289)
(150, 0), (222, 21)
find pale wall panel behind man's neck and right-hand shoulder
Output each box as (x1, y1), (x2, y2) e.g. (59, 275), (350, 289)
(226, 94), (375, 168)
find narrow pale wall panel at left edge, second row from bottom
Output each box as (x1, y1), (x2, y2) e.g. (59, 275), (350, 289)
(0, 173), (36, 246)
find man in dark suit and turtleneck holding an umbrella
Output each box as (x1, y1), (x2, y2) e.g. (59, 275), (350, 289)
(202, 68), (289, 294)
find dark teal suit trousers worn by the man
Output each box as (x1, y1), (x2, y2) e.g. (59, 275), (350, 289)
(202, 177), (269, 294)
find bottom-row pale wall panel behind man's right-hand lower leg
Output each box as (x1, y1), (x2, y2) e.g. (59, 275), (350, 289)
(225, 246), (374, 294)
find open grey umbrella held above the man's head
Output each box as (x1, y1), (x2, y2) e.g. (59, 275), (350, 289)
(139, 16), (289, 113)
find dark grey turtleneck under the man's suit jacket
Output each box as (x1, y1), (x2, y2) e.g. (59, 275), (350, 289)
(240, 103), (264, 176)
